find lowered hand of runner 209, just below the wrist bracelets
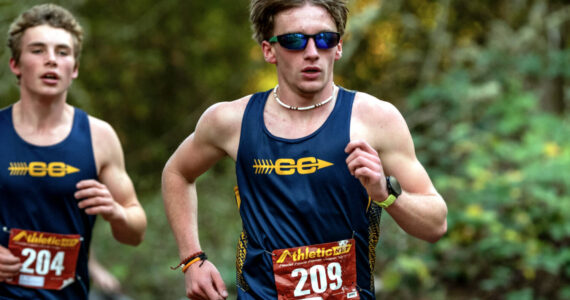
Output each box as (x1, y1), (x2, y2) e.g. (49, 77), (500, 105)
(185, 260), (228, 300)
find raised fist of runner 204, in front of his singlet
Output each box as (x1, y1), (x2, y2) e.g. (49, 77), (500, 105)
(75, 179), (127, 221)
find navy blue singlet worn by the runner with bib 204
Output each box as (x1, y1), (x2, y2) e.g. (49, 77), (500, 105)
(0, 106), (97, 300)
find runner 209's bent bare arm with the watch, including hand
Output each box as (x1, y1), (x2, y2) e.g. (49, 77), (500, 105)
(346, 99), (447, 242)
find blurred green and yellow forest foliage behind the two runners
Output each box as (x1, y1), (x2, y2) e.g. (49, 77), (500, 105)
(0, 0), (570, 300)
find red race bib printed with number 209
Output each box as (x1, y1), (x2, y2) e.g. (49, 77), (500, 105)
(272, 239), (360, 300)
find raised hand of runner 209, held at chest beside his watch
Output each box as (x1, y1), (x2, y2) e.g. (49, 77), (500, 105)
(344, 140), (388, 201)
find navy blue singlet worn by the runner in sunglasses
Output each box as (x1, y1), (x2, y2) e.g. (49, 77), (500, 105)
(236, 88), (381, 299)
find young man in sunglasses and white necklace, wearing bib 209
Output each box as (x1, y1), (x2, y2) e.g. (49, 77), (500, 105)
(163, 0), (447, 299)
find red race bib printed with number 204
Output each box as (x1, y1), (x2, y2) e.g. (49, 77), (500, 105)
(6, 228), (81, 290)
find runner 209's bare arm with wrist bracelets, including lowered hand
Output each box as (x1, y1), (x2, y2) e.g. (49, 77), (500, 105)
(162, 102), (234, 299)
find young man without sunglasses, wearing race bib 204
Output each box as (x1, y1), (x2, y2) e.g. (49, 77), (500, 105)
(0, 4), (146, 299)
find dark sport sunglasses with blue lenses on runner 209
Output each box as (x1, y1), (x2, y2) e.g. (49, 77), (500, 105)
(268, 31), (340, 50)
